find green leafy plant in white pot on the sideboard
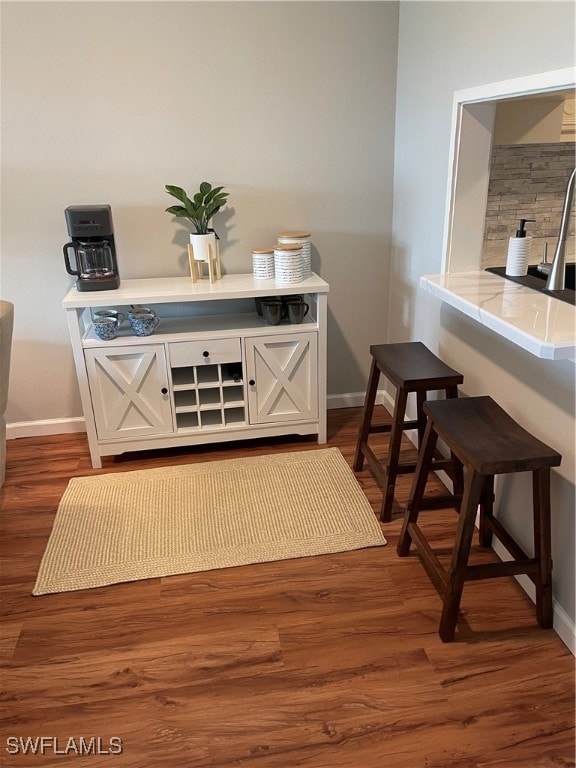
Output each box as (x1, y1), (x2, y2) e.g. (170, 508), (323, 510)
(165, 181), (229, 261)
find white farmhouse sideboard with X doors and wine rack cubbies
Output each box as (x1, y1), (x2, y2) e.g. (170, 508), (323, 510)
(62, 274), (329, 467)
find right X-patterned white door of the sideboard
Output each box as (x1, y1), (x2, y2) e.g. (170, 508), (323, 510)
(246, 333), (318, 424)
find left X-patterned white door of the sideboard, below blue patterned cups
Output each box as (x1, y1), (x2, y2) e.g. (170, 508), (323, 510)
(84, 344), (173, 440)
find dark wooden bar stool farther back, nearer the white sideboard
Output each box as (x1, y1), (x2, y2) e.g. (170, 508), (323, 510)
(353, 341), (464, 522)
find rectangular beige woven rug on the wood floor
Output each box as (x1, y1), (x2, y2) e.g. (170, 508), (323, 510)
(32, 448), (386, 595)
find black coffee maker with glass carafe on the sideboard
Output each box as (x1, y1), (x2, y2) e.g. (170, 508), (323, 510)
(64, 205), (120, 291)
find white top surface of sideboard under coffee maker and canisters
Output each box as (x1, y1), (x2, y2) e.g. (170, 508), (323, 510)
(62, 273), (329, 309)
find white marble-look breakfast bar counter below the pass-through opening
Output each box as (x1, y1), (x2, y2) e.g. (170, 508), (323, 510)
(420, 270), (576, 360)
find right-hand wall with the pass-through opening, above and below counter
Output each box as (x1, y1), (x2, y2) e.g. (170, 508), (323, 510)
(388, 2), (575, 646)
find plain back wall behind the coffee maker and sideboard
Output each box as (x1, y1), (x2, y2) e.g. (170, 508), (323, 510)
(0, 2), (398, 423)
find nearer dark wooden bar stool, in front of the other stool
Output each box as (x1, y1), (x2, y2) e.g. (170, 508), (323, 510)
(398, 397), (562, 643)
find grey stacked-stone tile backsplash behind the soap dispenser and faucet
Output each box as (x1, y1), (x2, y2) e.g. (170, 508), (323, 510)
(482, 141), (576, 268)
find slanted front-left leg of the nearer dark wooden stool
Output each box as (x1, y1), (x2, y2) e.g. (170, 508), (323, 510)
(439, 470), (484, 643)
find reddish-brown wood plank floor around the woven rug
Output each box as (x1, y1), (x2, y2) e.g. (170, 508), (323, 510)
(0, 409), (574, 768)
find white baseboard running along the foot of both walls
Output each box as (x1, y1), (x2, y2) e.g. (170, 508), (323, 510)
(6, 390), (576, 656)
